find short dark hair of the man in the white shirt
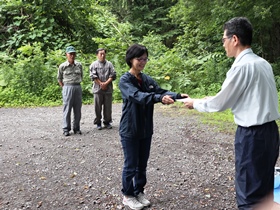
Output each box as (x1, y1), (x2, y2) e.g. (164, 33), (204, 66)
(224, 17), (253, 46)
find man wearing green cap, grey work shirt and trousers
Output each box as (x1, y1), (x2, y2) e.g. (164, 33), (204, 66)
(57, 46), (83, 136)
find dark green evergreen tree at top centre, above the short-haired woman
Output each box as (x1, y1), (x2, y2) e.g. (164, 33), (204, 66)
(110, 0), (179, 48)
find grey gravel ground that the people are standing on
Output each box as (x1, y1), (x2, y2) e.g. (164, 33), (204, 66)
(0, 104), (280, 210)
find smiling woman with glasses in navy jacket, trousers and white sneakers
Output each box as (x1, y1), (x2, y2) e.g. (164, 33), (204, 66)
(119, 44), (188, 209)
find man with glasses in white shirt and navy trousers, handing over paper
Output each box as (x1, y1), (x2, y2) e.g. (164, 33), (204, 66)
(185, 17), (280, 210)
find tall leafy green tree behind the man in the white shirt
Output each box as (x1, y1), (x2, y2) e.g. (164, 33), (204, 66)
(167, 0), (280, 94)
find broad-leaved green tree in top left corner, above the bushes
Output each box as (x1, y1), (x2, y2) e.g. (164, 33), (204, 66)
(0, 0), (98, 52)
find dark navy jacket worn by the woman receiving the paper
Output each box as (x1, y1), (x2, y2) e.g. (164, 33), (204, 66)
(119, 72), (181, 139)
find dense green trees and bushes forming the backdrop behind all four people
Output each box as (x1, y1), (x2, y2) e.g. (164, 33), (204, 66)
(0, 0), (280, 110)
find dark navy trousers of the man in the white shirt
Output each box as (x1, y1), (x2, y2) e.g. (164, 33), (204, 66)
(235, 121), (279, 210)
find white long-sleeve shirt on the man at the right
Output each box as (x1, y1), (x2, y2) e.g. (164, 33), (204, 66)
(193, 48), (280, 127)
